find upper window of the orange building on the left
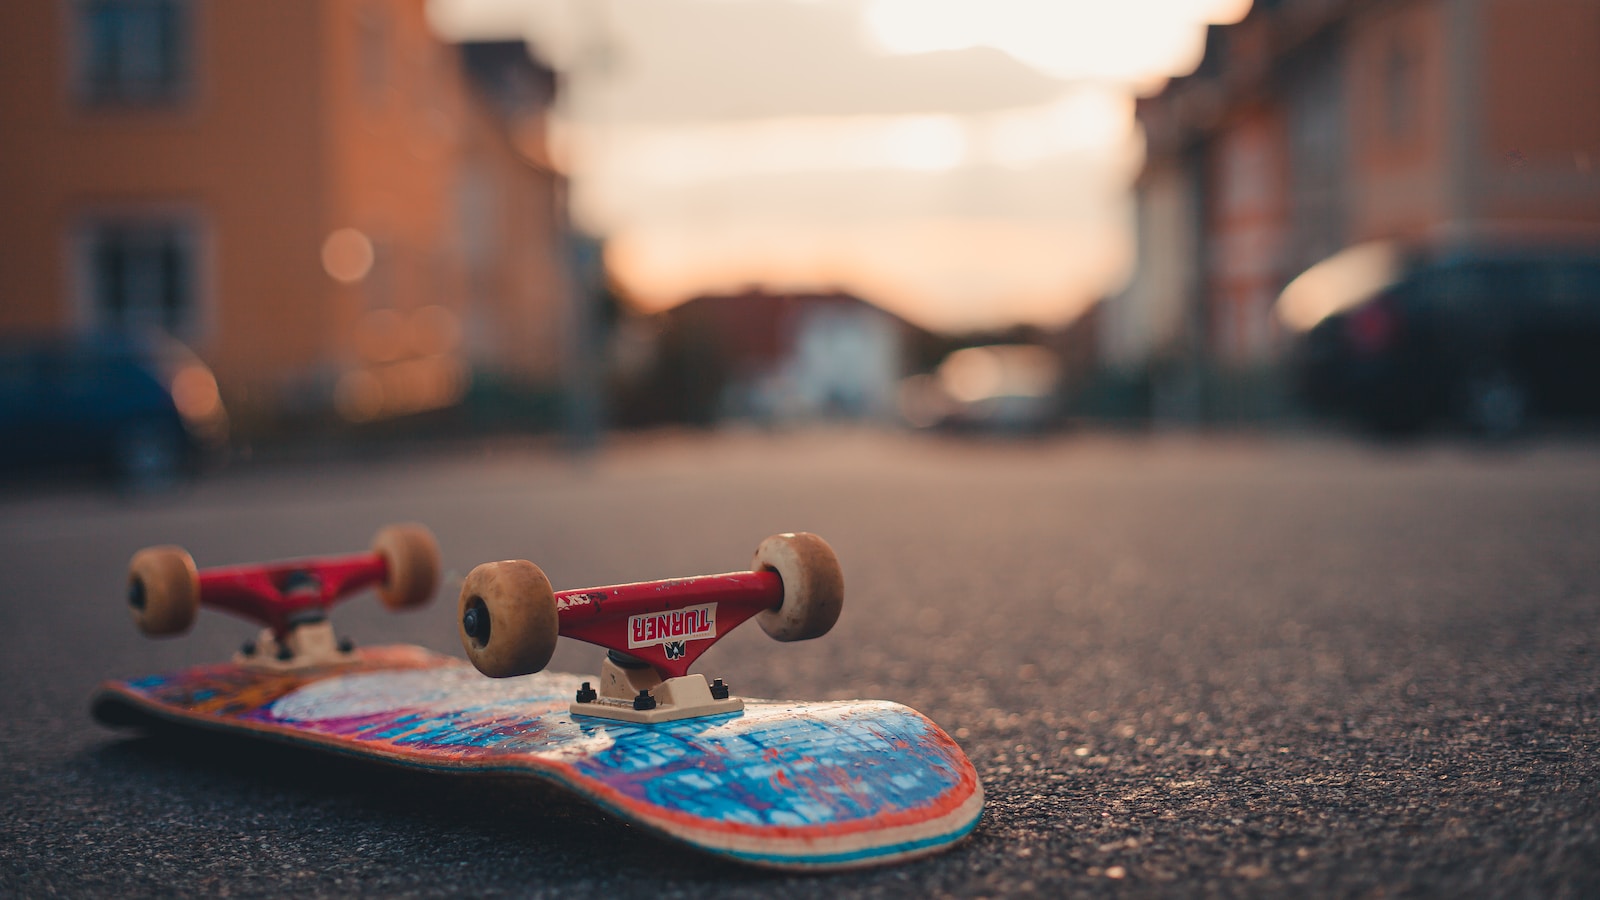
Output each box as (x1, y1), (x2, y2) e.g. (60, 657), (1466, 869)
(75, 0), (194, 106)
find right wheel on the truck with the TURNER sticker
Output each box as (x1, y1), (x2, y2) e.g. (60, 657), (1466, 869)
(750, 532), (845, 641)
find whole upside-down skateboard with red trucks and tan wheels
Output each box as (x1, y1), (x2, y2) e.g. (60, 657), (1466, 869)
(93, 525), (984, 871)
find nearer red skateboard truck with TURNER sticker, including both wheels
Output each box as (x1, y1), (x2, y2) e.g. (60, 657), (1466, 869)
(458, 532), (845, 722)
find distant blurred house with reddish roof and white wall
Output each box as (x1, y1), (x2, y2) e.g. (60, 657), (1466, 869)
(613, 290), (920, 424)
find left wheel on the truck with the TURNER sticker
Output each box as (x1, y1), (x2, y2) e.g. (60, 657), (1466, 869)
(456, 559), (560, 677)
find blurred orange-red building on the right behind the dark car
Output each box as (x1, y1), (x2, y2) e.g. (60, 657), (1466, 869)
(1101, 0), (1600, 416)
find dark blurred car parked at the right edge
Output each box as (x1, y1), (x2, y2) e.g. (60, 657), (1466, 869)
(1296, 250), (1600, 436)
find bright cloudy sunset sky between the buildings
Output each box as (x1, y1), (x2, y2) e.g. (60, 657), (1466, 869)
(429, 0), (1250, 331)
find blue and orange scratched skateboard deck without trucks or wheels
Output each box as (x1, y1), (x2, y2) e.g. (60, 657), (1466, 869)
(94, 645), (984, 870)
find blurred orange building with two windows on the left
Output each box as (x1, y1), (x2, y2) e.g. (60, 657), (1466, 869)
(0, 0), (568, 420)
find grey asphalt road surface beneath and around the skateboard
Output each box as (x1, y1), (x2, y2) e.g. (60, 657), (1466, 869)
(0, 432), (1600, 898)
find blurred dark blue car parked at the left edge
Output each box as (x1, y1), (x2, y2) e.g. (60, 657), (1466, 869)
(0, 336), (227, 485)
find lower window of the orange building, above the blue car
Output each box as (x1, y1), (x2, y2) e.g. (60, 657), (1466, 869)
(80, 219), (200, 335)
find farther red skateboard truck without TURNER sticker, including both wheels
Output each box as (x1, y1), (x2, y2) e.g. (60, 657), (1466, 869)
(128, 524), (440, 668)
